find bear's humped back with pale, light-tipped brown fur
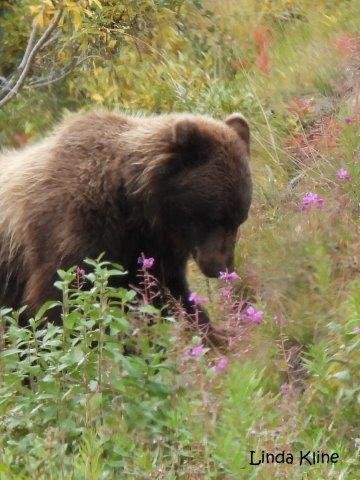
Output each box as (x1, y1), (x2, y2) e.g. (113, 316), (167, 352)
(0, 112), (136, 272)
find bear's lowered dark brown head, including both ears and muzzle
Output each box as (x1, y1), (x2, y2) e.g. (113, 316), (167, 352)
(129, 113), (252, 277)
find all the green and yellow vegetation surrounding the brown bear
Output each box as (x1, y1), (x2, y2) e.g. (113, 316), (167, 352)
(0, 0), (360, 480)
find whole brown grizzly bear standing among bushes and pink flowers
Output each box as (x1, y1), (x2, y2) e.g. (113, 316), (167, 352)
(0, 111), (252, 338)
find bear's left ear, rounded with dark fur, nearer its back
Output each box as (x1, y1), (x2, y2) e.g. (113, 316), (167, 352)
(173, 118), (207, 165)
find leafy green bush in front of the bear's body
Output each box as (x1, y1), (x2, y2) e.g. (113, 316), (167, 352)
(0, 260), (184, 478)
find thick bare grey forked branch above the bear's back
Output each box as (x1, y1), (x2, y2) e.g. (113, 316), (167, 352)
(0, 10), (63, 108)
